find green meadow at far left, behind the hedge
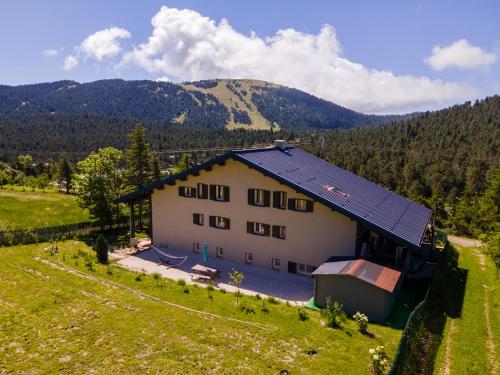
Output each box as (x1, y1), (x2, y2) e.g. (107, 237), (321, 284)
(0, 188), (90, 230)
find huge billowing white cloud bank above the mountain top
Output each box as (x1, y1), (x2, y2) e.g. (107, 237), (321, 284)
(120, 6), (474, 113)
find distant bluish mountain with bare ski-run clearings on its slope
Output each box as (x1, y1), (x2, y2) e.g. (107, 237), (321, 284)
(0, 79), (402, 130)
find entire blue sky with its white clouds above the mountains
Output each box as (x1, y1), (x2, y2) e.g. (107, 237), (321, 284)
(0, 0), (500, 113)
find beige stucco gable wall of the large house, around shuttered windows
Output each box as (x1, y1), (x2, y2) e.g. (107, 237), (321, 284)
(152, 160), (356, 272)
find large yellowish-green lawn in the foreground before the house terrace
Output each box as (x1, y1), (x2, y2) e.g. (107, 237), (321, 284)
(0, 241), (401, 375)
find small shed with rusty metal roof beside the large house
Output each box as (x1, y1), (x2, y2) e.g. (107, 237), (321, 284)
(313, 259), (401, 323)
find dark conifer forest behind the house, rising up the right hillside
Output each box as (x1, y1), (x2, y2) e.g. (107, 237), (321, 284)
(0, 96), (500, 244)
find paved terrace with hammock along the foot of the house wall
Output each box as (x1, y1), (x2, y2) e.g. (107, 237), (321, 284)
(118, 249), (314, 303)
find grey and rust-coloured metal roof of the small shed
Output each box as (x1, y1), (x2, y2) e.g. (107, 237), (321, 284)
(313, 259), (401, 293)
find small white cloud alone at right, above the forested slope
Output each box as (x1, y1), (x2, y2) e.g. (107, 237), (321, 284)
(425, 39), (496, 71)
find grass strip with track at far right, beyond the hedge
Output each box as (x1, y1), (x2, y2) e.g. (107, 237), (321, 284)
(434, 245), (500, 374)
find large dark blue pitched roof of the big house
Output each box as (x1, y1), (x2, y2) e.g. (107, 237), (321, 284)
(116, 147), (432, 248)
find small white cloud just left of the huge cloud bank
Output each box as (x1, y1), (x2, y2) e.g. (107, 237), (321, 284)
(64, 27), (130, 70)
